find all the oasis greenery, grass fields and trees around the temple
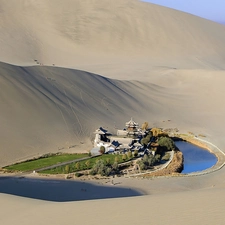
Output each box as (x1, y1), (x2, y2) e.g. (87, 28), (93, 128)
(4, 127), (176, 176)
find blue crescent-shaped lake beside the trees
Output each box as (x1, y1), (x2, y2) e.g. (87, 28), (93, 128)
(175, 141), (217, 173)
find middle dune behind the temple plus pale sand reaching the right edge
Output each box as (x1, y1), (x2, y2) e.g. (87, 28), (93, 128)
(0, 60), (225, 166)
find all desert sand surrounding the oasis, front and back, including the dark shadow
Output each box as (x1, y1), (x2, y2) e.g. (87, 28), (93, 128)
(0, 0), (225, 225)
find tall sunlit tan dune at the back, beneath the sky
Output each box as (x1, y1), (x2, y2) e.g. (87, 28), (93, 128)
(0, 0), (225, 72)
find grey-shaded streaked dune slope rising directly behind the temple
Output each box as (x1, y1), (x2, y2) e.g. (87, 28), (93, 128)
(0, 63), (174, 164)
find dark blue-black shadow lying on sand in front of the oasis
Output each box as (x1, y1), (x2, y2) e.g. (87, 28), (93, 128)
(0, 177), (142, 202)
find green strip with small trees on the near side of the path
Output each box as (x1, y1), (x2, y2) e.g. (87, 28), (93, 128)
(41, 154), (128, 174)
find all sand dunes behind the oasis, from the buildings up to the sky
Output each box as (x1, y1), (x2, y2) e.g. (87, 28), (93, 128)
(0, 0), (225, 165)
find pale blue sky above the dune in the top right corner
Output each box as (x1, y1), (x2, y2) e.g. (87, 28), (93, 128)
(143, 0), (225, 22)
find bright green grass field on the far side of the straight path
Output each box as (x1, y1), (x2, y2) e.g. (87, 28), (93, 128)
(4, 154), (88, 171)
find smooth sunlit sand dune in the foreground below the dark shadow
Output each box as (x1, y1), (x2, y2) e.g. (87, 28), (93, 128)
(0, 176), (225, 225)
